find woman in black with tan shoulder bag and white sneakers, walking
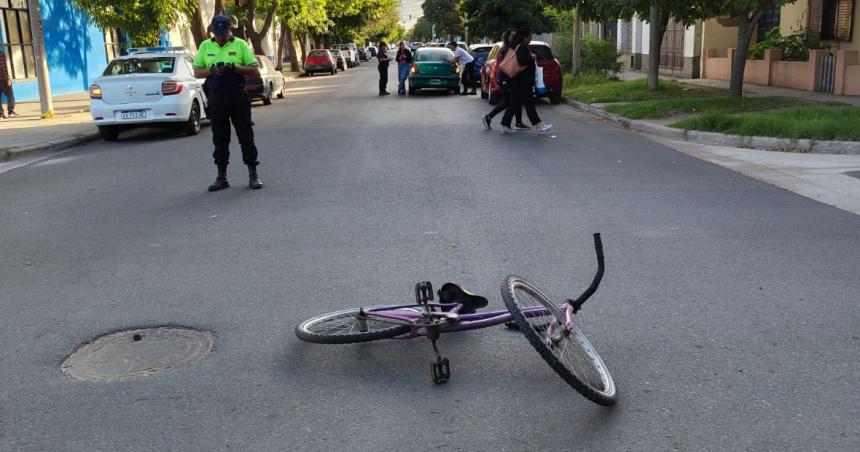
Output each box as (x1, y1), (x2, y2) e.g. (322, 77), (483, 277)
(502, 27), (552, 134)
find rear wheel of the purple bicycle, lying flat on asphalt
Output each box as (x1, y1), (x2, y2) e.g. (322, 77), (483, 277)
(296, 306), (410, 344)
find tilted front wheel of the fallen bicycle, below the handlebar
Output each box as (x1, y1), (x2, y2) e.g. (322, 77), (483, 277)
(502, 276), (617, 406)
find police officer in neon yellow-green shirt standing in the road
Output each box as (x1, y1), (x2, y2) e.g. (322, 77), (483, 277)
(194, 16), (263, 191)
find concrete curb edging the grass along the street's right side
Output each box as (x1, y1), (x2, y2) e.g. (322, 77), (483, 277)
(564, 99), (860, 155)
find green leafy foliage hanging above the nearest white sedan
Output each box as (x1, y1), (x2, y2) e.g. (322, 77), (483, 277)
(72, 0), (188, 46)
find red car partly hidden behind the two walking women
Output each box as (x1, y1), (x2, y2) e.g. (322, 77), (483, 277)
(481, 41), (563, 105)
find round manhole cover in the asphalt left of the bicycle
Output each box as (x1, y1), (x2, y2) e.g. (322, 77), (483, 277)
(60, 327), (214, 382)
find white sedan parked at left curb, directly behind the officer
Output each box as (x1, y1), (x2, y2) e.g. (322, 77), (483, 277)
(90, 47), (207, 141)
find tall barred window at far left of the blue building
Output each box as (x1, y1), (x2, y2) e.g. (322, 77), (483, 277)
(0, 0), (36, 80)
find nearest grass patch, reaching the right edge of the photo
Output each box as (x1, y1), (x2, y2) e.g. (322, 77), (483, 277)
(671, 106), (860, 141)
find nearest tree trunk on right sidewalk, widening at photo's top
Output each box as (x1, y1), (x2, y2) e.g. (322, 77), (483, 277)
(709, 0), (796, 97)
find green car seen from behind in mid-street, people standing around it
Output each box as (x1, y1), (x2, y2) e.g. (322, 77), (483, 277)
(409, 47), (460, 96)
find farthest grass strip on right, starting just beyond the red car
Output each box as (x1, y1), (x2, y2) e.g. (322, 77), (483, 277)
(564, 75), (724, 104)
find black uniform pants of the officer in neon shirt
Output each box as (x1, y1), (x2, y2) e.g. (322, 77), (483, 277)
(209, 90), (259, 166)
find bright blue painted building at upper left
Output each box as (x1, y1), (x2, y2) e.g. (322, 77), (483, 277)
(0, 0), (143, 100)
